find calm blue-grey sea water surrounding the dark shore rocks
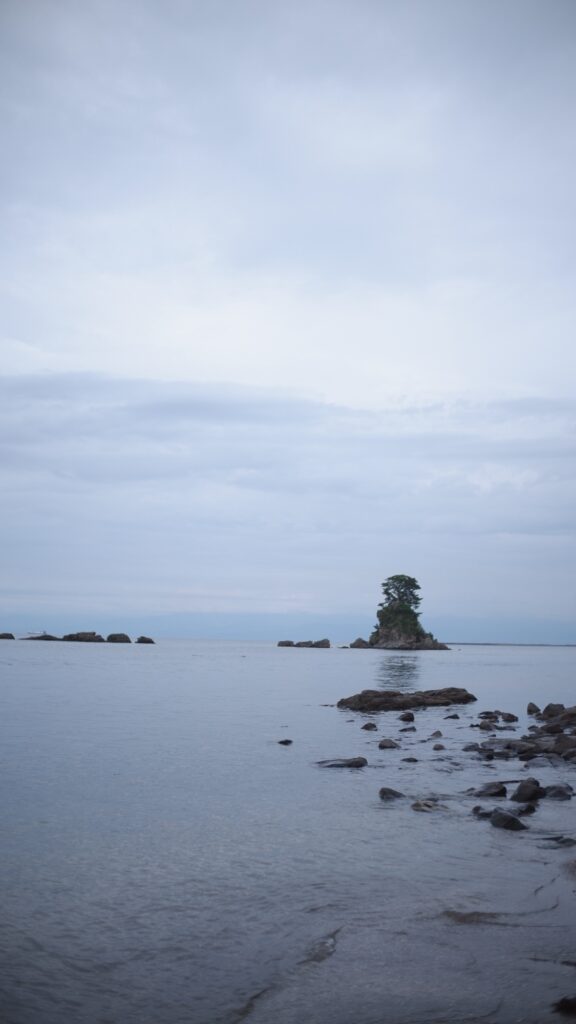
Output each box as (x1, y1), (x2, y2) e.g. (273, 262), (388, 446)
(0, 641), (576, 1024)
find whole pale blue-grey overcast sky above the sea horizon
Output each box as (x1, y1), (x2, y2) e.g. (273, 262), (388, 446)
(0, 0), (576, 642)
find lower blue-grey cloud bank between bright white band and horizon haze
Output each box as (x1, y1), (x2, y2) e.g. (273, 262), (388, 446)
(0, 375), (576, 628)
